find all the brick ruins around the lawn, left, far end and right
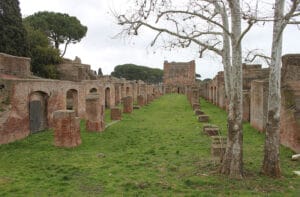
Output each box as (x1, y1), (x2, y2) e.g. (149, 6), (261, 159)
(0, 53), (300, 152)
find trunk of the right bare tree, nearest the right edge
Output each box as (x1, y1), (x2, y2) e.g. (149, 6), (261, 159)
(262, 0), (285, 177)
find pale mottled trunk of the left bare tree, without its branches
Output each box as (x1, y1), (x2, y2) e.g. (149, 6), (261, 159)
(221, 0), (243, 179)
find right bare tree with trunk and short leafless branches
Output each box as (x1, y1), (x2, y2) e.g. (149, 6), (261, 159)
(245, 0), (300, 178)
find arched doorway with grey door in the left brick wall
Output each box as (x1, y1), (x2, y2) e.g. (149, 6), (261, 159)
(29, 91), (48, 133)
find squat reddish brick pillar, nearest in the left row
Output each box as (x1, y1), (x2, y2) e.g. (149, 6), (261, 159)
(53, 110), (81, 148)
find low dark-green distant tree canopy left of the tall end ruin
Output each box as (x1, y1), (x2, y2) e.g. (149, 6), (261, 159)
(111, 64), (163, 83)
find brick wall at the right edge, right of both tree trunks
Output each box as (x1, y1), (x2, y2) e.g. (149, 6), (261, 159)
(280, 54), (300, 153)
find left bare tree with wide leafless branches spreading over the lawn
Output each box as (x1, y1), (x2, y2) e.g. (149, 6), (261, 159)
(116, 0), (256, 178)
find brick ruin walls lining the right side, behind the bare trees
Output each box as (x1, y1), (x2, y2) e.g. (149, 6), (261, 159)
(200, 54), (300, 153)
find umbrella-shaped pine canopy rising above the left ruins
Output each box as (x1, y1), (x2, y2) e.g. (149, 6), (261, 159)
(24, 11), (87, 56)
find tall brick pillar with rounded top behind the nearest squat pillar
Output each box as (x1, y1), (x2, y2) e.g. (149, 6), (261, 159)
(85, 93), (105, 132)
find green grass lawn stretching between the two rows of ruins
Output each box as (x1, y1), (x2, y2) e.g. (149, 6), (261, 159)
(0, 95), (300, 196)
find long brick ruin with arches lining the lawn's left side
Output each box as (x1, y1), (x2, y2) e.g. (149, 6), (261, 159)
(0, 53), (163, 147)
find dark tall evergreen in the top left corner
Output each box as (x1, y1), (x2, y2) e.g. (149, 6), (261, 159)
(0, 0), (28, 56)
